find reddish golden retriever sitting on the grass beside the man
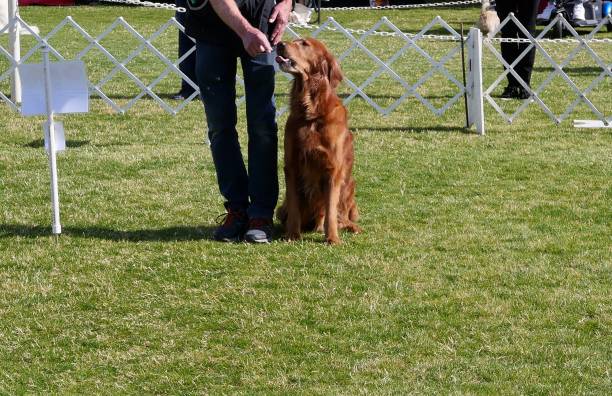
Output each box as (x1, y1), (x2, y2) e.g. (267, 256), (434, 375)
(276, 38), (360, 244)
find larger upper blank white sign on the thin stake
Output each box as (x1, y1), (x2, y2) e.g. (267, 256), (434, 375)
(19, 61), (89, 116)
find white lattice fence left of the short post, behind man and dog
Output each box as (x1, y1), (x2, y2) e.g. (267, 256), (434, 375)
(0, 17), (465, 119)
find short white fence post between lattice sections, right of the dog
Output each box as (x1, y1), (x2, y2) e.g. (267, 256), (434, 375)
(466, 28), (485, 135)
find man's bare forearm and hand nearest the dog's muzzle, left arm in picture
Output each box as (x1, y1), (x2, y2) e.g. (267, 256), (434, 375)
(210, 0), (272, 56)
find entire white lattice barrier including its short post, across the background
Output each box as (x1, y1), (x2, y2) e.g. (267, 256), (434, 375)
(0, 10), (612, 133)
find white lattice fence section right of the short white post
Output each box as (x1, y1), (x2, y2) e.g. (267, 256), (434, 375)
(483, 14), (612, 126)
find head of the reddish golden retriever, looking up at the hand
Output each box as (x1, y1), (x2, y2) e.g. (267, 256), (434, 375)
(276, 38), (342, 89)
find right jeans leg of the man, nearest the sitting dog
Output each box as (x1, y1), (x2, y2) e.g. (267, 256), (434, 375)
(241, 52), (278, 219)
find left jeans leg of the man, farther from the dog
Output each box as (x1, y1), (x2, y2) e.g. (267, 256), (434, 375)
(196, 41), (249, 212)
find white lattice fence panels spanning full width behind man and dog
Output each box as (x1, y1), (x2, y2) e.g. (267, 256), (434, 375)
(0, 10), (612, 131)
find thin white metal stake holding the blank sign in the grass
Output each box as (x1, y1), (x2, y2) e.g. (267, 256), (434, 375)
(42, 44), (62, 235)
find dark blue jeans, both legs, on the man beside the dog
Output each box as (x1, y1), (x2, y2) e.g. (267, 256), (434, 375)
(196, 41), (278, 218)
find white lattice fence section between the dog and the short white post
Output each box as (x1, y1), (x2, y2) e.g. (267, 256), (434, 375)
(280, 17), (465, 116)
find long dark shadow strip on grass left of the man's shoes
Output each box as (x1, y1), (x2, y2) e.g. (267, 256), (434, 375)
(0, 224), (216, 242)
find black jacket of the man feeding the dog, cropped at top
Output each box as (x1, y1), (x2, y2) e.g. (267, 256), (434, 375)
(185, 0), (276, 49)
